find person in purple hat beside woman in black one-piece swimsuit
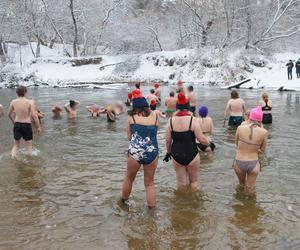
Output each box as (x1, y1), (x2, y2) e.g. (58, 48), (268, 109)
(197, 106), (216, 152)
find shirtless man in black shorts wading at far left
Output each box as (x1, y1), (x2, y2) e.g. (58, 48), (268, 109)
(8, 86), (42, 158)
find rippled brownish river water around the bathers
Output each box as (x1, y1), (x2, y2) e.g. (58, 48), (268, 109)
(0, 87), (300, 249)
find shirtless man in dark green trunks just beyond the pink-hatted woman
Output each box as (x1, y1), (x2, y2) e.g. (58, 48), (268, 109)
(224, 90), (246, 126)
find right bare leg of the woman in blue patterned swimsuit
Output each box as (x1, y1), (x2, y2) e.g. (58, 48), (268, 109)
(144, 158), (158, 208)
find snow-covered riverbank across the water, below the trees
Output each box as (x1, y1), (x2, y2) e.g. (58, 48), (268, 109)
(0, 44), (300, 90)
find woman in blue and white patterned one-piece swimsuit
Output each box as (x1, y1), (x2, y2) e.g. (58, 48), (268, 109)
(122, 92), (159, 208)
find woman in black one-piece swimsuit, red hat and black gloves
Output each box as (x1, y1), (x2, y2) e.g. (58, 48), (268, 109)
(165, 93), (210, 191)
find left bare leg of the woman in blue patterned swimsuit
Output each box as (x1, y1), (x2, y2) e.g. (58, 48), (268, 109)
(122, 155), (141, 200)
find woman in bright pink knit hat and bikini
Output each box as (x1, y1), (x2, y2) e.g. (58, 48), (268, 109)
(233, 106), (268, 194)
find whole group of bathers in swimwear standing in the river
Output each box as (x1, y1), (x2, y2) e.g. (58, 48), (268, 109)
(0, 81), (272, 208)
